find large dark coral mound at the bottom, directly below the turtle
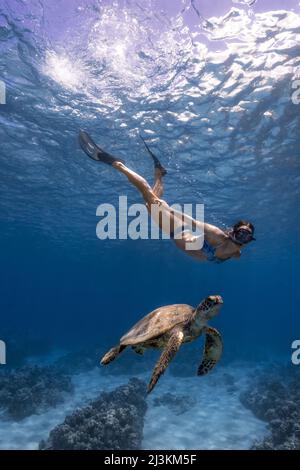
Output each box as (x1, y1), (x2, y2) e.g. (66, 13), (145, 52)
(40, 378), (147, 450)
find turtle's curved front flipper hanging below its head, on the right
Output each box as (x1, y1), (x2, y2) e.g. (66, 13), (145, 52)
(197, 326), (223, 375)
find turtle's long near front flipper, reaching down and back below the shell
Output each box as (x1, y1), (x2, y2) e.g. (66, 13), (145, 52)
(148, 328), (184, 393)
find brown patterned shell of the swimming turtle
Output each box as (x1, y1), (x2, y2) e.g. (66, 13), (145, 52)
(120, 304), (195, 346)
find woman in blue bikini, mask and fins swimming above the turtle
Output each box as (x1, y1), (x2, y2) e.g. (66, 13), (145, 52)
(79, 131), (255, 263)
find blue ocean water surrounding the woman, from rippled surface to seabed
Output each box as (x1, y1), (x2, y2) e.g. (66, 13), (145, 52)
(0, 0), (300, 450)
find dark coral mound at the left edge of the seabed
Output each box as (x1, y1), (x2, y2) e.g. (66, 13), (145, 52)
(0, 366), (73, 421)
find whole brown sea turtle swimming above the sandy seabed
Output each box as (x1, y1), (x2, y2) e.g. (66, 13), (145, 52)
(101, 295), (223, 393)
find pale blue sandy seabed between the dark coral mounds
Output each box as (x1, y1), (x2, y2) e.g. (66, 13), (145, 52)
(0, 365), (267, 450)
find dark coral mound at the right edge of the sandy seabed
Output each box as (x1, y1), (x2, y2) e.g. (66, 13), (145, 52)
(240, 368), (300, 450)
